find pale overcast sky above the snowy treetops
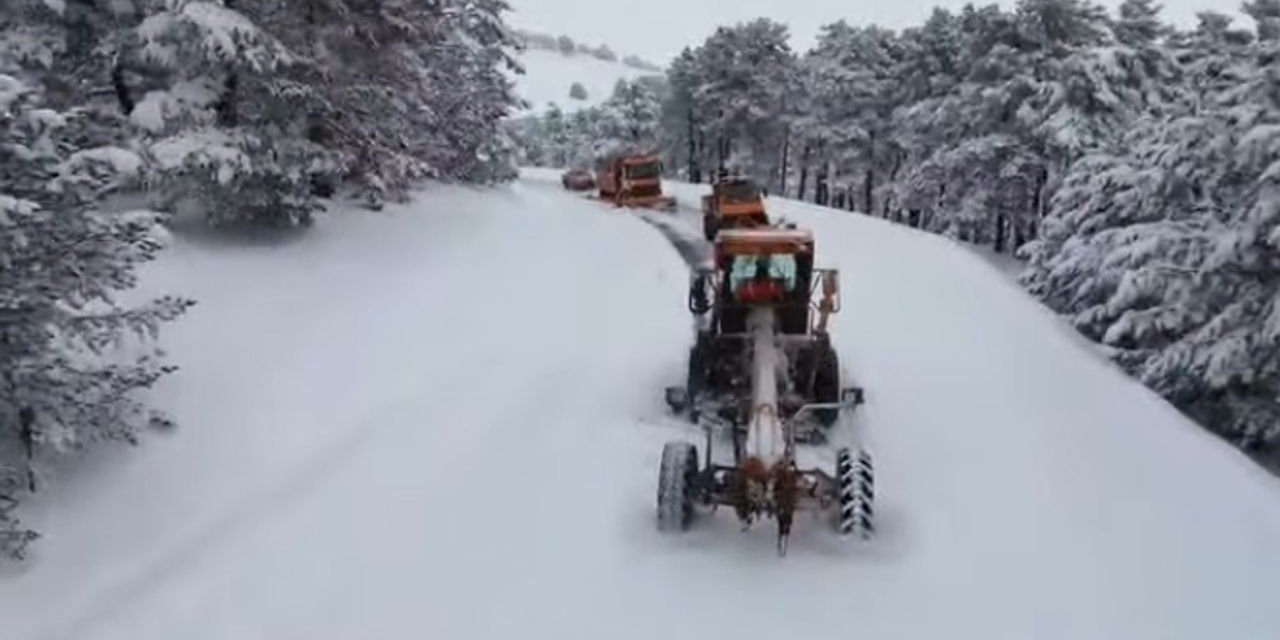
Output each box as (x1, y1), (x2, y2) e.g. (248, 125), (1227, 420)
(507, 0), (1252, 64)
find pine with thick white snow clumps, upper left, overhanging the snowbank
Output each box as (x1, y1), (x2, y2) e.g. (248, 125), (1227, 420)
(131, 0), (319, 227)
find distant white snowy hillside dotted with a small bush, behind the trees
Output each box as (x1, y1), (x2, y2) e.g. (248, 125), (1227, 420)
(512, 49), (654, 113)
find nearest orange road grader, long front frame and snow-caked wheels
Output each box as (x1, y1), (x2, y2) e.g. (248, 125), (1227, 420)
(658, 228), (874, 554)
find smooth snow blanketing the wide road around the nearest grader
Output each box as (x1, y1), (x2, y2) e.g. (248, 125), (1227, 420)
(0, 172), (1280, 640)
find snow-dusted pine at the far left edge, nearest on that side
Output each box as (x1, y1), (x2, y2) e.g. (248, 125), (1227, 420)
(0, 67), (191, 556)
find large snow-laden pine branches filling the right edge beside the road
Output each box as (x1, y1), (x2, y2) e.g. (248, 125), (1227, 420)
(1024, 1), (1280, 460)
